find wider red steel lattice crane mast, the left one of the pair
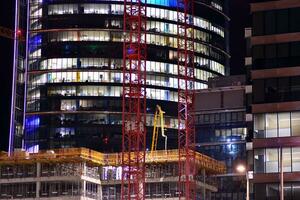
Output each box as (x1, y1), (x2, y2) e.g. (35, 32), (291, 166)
(121, 0), (147, 200)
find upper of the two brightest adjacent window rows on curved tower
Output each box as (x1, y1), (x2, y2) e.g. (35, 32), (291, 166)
(37, 58), (225, 75)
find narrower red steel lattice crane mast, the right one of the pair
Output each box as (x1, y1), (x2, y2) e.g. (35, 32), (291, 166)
(177, 0), (196, 200)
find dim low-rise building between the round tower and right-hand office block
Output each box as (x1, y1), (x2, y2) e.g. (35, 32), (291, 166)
(195, 76), (247, 200)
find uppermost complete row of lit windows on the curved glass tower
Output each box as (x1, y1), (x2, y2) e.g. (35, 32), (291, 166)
(45, 4), (224, 37)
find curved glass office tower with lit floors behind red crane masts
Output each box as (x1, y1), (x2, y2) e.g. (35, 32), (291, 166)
(23, 0), (229, 152)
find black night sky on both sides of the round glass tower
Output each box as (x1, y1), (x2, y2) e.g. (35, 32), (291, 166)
(0, 0), (249, 151)
